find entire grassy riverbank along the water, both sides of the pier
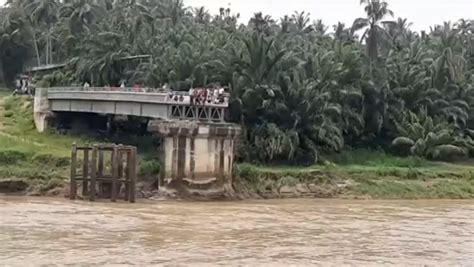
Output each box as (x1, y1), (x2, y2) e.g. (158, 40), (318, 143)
(0, 96), (474, 199)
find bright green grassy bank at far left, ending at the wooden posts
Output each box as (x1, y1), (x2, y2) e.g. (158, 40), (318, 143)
(0, 94), (85, 195)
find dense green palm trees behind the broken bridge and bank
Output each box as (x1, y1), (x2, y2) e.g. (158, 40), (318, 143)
(0, 0), (474, 163)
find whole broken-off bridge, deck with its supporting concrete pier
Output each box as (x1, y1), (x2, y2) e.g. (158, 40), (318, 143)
(34, 87), (240, 198)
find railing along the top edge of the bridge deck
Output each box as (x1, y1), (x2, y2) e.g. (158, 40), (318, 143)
(47, 87), (230, 107)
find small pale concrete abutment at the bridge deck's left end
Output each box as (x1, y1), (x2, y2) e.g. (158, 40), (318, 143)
(33, 88), (53, 133)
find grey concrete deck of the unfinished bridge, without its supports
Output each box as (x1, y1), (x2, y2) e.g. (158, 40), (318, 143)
(42, 87), (229, 122)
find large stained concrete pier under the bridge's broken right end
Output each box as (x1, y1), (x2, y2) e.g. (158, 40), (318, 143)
(148, 121), (240, 195)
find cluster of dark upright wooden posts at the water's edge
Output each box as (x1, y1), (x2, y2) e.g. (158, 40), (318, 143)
(70, 144), (137, 203)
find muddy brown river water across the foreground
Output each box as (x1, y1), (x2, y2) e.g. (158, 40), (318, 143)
(0, 196), (474, 266)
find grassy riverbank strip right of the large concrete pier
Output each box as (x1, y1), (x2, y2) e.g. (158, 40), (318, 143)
(235, 150), (474, 199)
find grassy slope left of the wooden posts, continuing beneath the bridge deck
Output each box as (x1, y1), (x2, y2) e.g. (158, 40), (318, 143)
(0, 94), (160, 194)
